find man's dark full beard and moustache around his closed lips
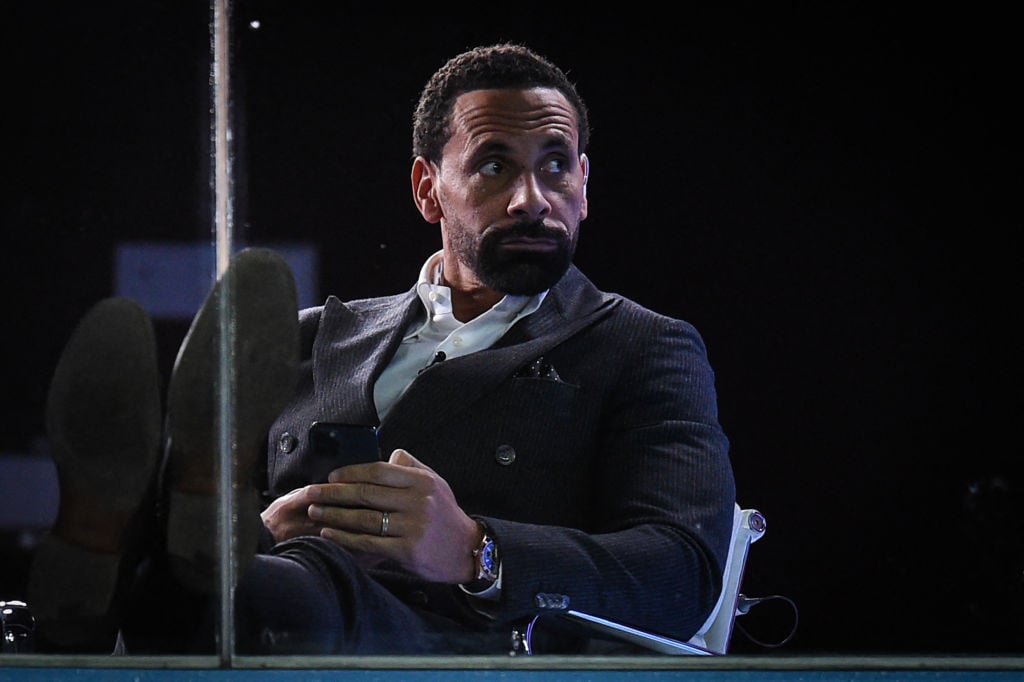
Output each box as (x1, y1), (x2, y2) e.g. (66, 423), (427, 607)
(452, 220), (579, 296)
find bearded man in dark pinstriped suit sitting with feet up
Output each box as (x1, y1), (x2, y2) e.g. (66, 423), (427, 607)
(28, 44), (734, 653)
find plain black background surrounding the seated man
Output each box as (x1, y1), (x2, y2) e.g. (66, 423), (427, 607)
(0, 0), (1024, 654)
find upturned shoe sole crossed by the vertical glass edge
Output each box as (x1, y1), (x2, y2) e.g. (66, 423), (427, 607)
(165, 248), (299, 593)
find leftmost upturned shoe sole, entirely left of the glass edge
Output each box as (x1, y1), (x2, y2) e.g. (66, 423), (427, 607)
(27, 297), (161, 652)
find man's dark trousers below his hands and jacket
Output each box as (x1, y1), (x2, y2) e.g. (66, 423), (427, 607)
(122, 537), (512, 655)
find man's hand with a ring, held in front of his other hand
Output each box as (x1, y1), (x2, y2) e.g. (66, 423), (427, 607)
(303, 450), (482, 585)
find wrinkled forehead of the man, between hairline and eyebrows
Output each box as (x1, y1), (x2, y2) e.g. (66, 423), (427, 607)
(452, 88), (577, 140)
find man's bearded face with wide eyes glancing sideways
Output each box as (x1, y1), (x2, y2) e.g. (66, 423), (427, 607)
(432, 88), (588, 295)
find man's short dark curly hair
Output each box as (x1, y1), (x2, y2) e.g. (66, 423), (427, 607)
(413, 43), (590, 163)
